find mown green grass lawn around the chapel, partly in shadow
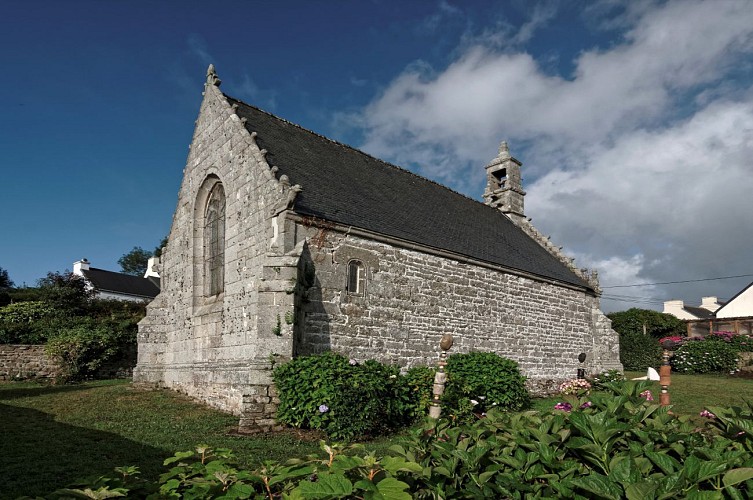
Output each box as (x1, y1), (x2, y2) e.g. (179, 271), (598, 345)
(0, 373), (753, 499)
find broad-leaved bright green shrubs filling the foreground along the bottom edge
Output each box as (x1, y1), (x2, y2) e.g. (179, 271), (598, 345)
(46, 382), (753, 500)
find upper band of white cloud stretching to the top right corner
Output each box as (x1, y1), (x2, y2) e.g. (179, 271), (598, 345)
(364, 2), (753, 165)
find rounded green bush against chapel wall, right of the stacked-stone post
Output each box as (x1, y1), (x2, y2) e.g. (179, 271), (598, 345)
(443, 352), (530, 421)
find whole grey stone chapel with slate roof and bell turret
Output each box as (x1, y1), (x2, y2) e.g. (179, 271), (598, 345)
(134, 66), (622, 431)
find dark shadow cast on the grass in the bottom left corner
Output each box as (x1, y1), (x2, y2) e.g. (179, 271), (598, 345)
(0, 404), (172, 499)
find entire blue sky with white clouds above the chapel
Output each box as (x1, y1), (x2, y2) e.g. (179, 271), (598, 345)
(0, 0), (753, 310)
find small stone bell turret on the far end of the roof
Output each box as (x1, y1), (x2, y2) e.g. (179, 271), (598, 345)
(484, 141), (526, 223)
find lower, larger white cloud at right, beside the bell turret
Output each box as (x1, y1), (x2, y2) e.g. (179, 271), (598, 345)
(526, 100), (753, 284)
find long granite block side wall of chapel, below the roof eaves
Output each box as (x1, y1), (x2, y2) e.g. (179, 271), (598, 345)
(296, 227), (621, 392)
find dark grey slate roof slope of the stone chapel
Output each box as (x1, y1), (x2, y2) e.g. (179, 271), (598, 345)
(225, 95), (591, 290)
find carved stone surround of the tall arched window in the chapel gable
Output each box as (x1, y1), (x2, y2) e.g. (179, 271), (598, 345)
(193, 173), (227, 310)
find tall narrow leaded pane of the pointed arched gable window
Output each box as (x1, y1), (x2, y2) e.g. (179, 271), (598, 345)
(204, 182), (225, 296)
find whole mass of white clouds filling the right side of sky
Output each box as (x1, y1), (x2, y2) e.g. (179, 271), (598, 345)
(359, 1), (753, 308)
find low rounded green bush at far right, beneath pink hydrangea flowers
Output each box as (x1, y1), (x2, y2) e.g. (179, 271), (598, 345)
(670, 340), (739, 373)
